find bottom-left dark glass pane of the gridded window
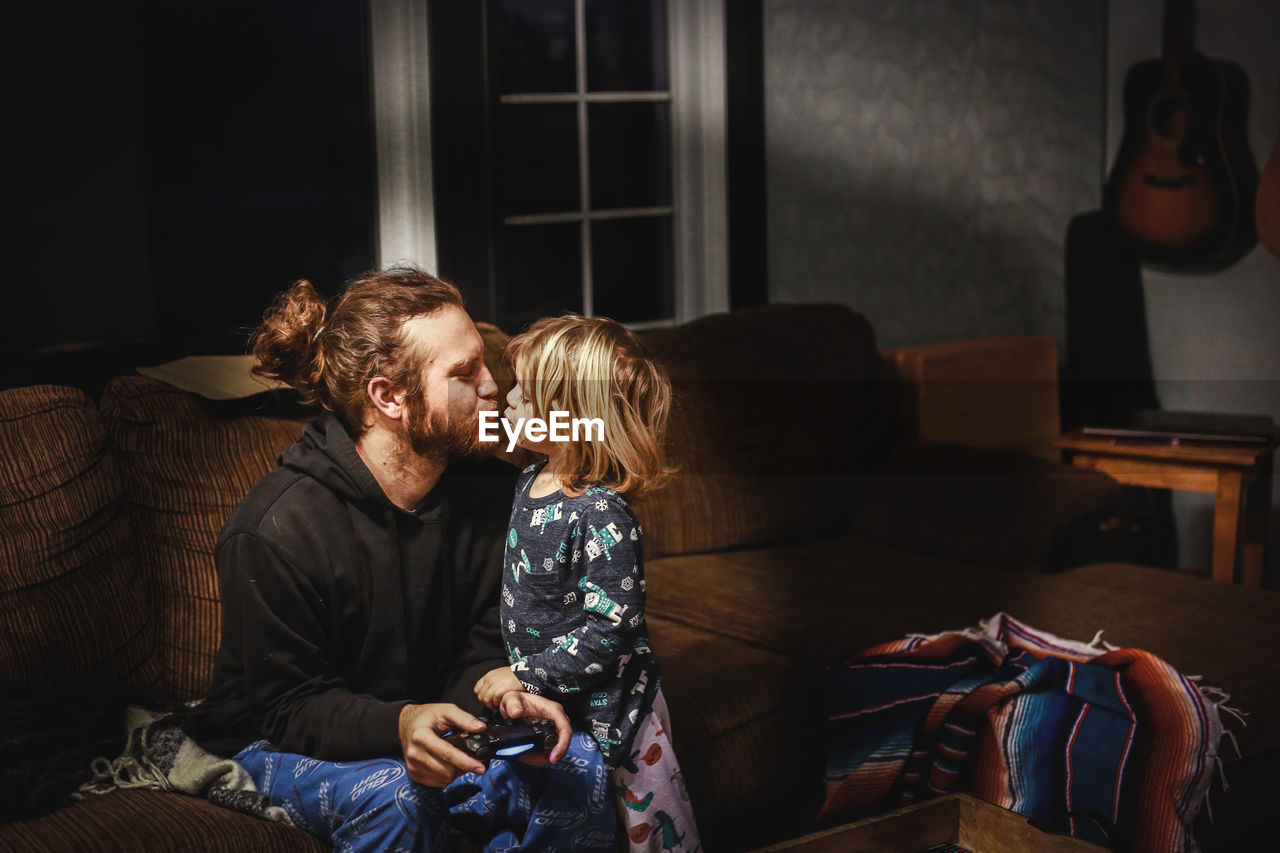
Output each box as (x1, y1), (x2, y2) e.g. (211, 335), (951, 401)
(497, 222), (582, 334)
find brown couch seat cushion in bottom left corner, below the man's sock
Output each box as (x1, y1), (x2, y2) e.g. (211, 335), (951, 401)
(0, 789), (329, 853)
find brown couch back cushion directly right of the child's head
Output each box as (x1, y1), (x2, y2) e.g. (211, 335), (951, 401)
(635, 305), (887, 556)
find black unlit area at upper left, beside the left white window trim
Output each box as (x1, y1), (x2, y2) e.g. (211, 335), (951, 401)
(6, 0), (376, 378)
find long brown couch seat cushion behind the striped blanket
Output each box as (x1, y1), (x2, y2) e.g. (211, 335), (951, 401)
(645, 537), (1280, 758)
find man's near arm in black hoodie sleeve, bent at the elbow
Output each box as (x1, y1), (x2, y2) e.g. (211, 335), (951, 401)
(215, 533), (407, 761)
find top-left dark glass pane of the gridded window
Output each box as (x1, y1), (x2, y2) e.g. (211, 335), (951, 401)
(490, 0), (577, 95)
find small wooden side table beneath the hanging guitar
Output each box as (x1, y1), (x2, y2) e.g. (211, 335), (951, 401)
(1053, 430), (1277, 587)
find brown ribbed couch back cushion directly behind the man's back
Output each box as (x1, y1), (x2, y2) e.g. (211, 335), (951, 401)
(102, 377), (308, 699)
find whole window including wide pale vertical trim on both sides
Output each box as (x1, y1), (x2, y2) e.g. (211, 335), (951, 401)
(371, 0), (728, 332)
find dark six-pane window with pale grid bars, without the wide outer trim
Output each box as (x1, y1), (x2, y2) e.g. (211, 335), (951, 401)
(489, 0), (676, 328)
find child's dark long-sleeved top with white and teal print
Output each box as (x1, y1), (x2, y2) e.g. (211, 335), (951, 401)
(500, 461), (658, 767)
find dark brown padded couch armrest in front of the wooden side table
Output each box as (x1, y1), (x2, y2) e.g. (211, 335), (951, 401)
(852, 443), (1124, 571)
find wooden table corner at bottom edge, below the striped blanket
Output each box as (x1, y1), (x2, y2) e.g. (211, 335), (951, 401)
(756, 794), (1102, 853)
